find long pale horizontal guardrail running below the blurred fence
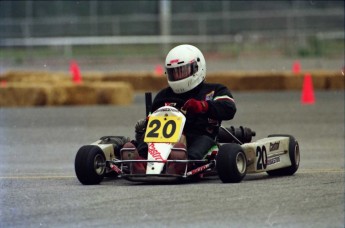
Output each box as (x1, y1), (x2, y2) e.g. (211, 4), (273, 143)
(0, 31), (344, 47)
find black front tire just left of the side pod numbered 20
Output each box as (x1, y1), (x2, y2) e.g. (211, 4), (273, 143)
(216, 143), (247, 183)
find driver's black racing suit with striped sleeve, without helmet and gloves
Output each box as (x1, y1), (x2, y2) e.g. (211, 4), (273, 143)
(144, 82), (236, 159)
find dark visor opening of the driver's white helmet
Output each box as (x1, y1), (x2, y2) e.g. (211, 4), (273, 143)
(166, 62), (198, 81)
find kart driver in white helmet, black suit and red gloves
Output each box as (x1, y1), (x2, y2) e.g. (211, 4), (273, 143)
(123, 44), (236, 173)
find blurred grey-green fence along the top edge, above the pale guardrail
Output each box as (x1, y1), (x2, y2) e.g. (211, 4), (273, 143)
(0, 0), (344, 39)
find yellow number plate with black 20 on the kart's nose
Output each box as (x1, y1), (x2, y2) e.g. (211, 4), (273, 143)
(144, 116), (182, 143)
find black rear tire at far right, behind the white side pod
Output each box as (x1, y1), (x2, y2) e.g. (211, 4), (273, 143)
(267, 134), (300, 176)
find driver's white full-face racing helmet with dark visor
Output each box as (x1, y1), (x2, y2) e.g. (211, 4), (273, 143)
(165, 44), (206, 93)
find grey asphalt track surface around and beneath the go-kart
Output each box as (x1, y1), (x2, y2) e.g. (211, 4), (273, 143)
(0, 91), (344, 227)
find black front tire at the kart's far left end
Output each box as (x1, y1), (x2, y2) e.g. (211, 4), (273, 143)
(74, 145), (106, 185)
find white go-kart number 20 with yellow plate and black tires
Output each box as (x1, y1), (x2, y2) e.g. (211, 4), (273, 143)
(75, 93), (300, 185)
